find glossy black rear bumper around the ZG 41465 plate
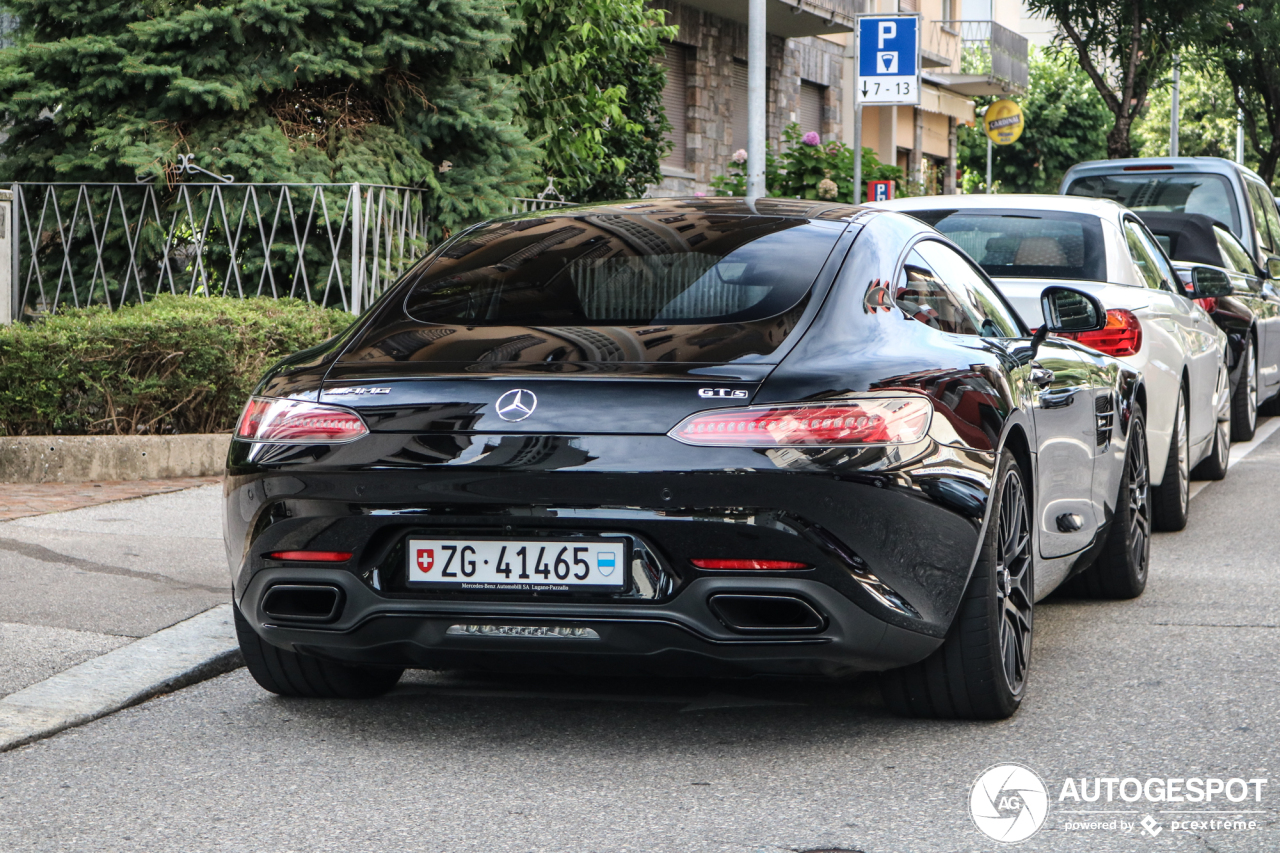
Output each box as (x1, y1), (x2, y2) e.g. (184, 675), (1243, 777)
(224, 435), (995, 675)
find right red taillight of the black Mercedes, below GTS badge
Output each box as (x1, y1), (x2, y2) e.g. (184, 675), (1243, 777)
(667, 397), (933, 447)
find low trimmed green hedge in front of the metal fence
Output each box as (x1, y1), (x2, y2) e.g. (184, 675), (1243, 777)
(0, 296), (352, 435)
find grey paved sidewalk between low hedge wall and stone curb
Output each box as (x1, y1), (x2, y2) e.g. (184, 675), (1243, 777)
(0, 478), (230, 697)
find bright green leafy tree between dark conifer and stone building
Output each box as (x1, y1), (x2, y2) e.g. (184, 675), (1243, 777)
(506, 0), (676, 201)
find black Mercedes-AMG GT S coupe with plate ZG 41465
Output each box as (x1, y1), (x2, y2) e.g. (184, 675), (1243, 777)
(224, 199), (1149, 719)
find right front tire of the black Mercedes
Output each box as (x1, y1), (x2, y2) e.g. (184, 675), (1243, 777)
(1065, 409), (1151, 598)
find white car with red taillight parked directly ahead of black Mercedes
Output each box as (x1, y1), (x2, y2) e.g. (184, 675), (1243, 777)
(873, 195), (1230, 530)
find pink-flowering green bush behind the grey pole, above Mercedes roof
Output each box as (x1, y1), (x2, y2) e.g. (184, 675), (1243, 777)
(712, 123), (902, 204)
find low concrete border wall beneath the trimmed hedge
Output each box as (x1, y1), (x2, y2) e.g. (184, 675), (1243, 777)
(0, 433), (232, 483)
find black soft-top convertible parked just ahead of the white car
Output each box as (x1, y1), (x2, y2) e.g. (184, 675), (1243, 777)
(1140, 213), (1280, 442)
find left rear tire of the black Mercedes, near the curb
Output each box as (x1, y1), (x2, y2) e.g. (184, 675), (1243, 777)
(232, 607), (404, 699)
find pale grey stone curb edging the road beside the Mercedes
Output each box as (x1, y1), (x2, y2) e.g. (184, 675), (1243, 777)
(0, 605), (243, 752)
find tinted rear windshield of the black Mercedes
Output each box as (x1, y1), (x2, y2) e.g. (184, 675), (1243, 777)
(404, 213), (845, 327)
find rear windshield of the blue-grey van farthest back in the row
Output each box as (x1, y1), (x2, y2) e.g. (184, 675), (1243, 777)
(1066, 172), (1240, 234)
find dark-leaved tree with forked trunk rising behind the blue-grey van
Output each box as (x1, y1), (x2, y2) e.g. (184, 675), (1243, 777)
(1027, 0), (1222, 158)
